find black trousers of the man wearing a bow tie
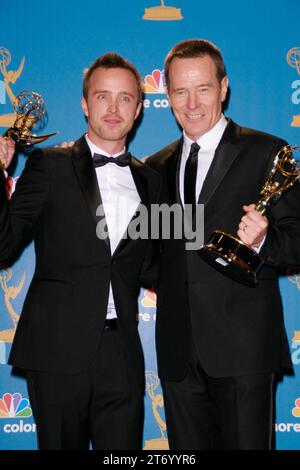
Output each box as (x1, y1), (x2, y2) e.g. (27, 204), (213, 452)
(27, 331), (144, 450)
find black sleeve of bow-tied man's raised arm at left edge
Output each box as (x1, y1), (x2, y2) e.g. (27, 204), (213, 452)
(0, 150), (49, 266)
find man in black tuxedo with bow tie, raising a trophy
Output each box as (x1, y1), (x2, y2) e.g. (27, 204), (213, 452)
(0, 53), (160, 450)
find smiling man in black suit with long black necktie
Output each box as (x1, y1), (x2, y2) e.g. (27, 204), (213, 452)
(147, 39), (300, 450)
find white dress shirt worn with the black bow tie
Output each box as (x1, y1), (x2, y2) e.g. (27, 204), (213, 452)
(85, 135), (141, 319)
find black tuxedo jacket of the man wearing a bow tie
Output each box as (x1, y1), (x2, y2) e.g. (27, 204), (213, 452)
(0, 137), (160, 382)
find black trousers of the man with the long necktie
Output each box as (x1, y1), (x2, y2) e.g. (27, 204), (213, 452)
(162, 346), (274, 450)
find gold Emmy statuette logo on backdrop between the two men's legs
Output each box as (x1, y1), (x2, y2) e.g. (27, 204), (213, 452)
(144, 371), (169, 450)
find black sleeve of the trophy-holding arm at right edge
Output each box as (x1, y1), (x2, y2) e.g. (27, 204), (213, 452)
(260, 143), (300, 268)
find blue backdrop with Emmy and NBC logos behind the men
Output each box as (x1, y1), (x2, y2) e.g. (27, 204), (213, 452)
(0, 0), (300, 449)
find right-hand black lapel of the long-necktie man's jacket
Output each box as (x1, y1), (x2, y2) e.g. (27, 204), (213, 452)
(198, 120), (239, 205)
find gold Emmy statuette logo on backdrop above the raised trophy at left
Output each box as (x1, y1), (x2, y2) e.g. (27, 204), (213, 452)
(0, 47), (25, 127)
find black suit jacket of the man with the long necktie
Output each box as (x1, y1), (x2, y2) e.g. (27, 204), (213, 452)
(147, 120), (300, 380)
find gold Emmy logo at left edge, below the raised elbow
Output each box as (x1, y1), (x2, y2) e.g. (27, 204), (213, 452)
(0, 269), (26, 343)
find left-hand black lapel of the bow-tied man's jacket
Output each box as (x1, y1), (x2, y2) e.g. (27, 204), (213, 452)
(72, 136), (110, 252)
